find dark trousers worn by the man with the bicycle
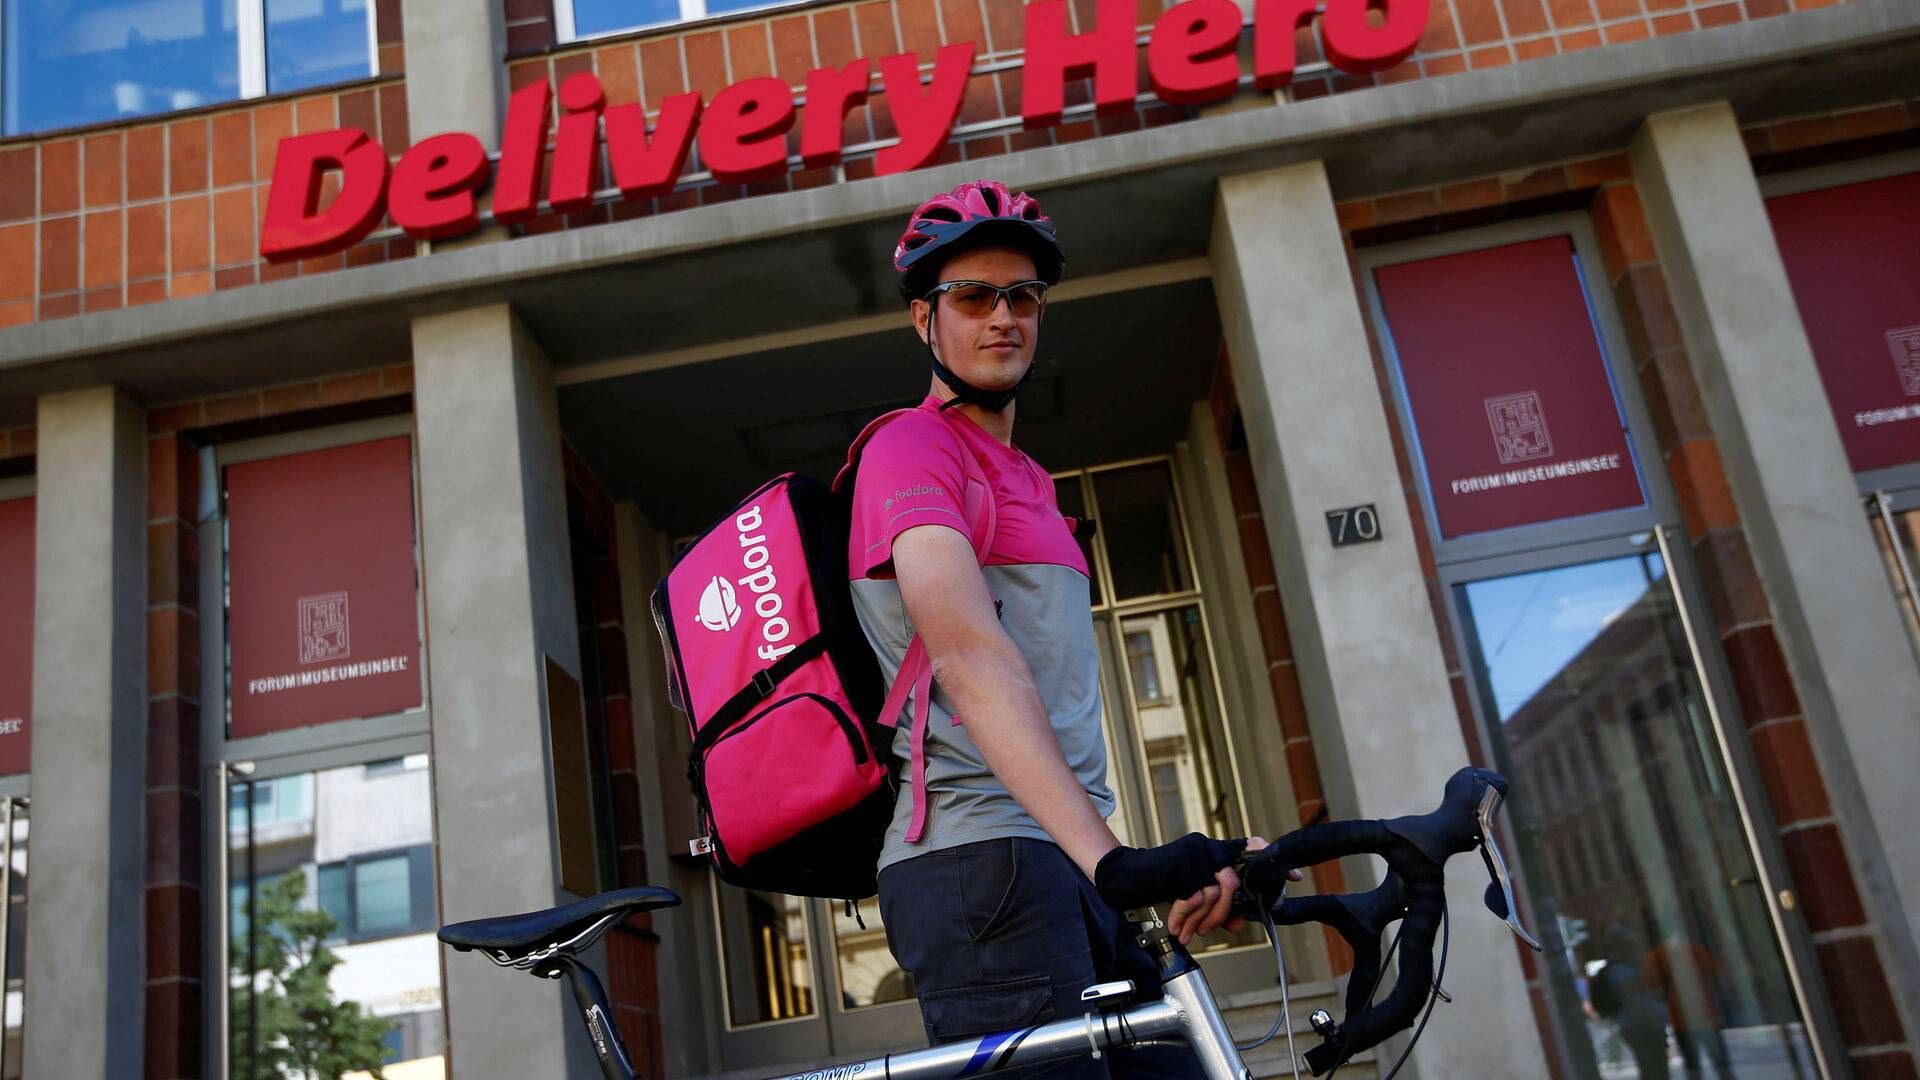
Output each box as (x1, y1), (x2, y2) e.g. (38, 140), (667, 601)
(879, 838), (1200, 1080)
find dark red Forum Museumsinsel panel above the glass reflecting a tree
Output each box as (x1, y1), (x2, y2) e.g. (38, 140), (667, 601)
(227, 436), (420, 738)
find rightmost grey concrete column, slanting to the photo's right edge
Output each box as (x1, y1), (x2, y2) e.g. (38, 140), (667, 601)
(1632, 102), (1920, 1006)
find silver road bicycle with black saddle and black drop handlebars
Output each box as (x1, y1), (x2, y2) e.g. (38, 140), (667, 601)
(440, 769), (1540, 1080)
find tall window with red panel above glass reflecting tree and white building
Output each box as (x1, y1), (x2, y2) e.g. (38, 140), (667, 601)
(211, 420), (445, 1080)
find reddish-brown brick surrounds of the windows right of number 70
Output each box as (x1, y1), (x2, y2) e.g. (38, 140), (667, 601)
(1338, 100), (1920, 1078)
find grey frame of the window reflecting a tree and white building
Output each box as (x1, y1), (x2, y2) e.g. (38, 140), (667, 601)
(200, 413), (447, 1080)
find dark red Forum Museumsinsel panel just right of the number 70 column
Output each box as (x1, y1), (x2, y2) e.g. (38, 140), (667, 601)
(1375, 236), (1644, 538)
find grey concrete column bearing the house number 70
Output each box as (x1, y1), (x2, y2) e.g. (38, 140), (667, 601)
(1210, 161), (1548, 1078)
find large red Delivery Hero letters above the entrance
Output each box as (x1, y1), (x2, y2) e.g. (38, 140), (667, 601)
(259, 0), (1428, 261)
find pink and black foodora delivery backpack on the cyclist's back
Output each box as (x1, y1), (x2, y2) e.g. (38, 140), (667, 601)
(653, 409), (995, 899)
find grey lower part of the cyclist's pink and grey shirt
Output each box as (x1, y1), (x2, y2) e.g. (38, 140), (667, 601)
(852, 565), (1114, 869)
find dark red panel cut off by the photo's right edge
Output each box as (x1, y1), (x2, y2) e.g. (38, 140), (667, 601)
(1766, 173), (1920, 471)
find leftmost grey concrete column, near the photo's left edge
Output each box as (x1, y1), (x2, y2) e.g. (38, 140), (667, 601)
(25, 386), (146, 1080)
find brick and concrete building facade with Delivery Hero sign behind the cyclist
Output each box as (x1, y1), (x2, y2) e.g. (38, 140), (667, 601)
(0, 0), (1920, 1080)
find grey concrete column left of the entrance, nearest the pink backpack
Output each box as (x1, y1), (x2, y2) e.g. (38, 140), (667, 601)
(413, 304), (597, 1080)
